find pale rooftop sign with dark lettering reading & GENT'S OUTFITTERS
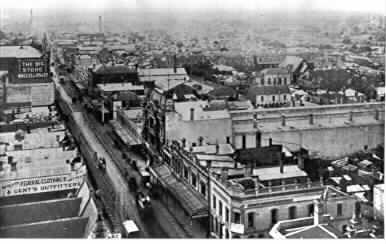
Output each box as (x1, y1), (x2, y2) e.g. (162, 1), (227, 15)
(0, 173), (84, 197)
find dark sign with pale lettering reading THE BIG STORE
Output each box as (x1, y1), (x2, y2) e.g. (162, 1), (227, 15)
(17, 58), (49, 79)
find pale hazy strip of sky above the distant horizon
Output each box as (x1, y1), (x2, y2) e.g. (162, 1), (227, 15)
(0, 0), (386, 15)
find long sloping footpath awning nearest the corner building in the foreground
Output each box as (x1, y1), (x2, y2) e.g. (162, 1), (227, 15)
(152, 165), (208, 218)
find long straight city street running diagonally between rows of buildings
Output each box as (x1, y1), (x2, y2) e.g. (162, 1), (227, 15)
(54, 67), (187, 238)
